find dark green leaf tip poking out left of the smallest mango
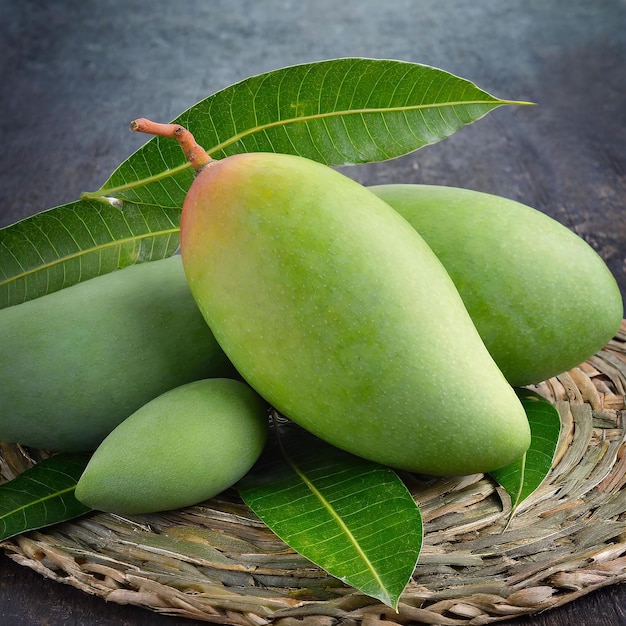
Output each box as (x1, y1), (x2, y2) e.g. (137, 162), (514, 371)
(0, 453), (90, 541)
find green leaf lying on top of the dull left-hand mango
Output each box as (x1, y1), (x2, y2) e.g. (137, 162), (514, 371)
(0, 201), (180, 309)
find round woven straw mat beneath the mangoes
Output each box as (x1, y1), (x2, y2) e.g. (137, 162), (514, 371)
(0, 322), (626, 626)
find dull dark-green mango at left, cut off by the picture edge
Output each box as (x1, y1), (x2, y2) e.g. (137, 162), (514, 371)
(0, 256), (233, 451)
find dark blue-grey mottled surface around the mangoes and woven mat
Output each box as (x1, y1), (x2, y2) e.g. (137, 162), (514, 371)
(0, 0), (626, 626)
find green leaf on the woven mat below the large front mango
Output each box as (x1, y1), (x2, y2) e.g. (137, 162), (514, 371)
(237, 416), (422, 608)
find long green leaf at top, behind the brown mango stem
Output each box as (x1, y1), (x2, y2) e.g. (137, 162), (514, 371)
(87, 58), (525, 206)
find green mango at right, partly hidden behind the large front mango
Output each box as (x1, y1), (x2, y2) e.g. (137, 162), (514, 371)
(369, 184), (623, 386)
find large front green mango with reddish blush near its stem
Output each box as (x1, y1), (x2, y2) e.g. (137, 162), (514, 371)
(181, 153), (530, 474)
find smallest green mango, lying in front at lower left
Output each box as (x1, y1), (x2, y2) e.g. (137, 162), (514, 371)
(75, 378), (268, 514)
